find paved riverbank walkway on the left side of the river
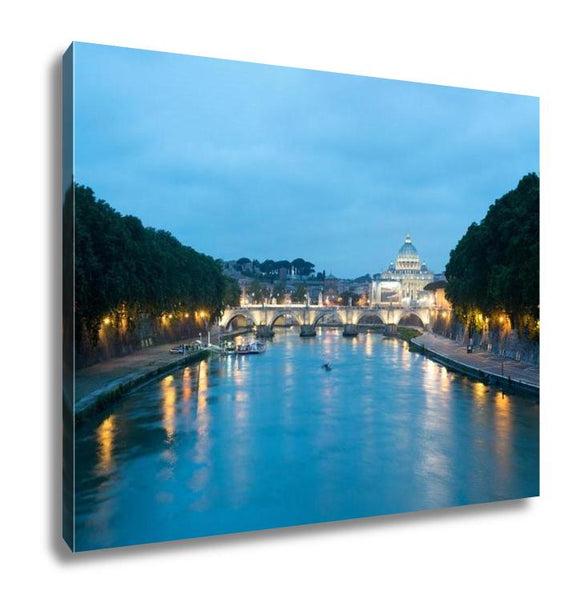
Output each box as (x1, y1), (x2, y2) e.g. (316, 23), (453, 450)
(75, 342), (208, 417)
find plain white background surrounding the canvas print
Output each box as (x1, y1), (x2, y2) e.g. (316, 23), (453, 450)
(0, 0), (580, 613)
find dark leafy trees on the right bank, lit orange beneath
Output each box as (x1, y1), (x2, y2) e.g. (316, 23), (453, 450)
(445, 173), (540, 335)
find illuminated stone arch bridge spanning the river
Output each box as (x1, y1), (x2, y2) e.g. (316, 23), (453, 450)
(218, 303), (448, 330)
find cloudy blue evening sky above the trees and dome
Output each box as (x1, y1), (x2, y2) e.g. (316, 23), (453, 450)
(74, 43), (539, 277)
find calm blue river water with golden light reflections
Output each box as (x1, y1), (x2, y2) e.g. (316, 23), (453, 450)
(76, 329), (539, 550)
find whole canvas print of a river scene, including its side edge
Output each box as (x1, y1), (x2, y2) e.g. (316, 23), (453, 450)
(62, 43), (540, 551)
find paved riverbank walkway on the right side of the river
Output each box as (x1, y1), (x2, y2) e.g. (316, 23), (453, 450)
(411, 333), (540, 391)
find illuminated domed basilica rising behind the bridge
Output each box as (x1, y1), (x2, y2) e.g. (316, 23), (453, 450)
(369, 235), (434, 307)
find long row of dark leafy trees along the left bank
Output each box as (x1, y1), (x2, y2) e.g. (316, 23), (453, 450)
(72, 184), (240, 346)
